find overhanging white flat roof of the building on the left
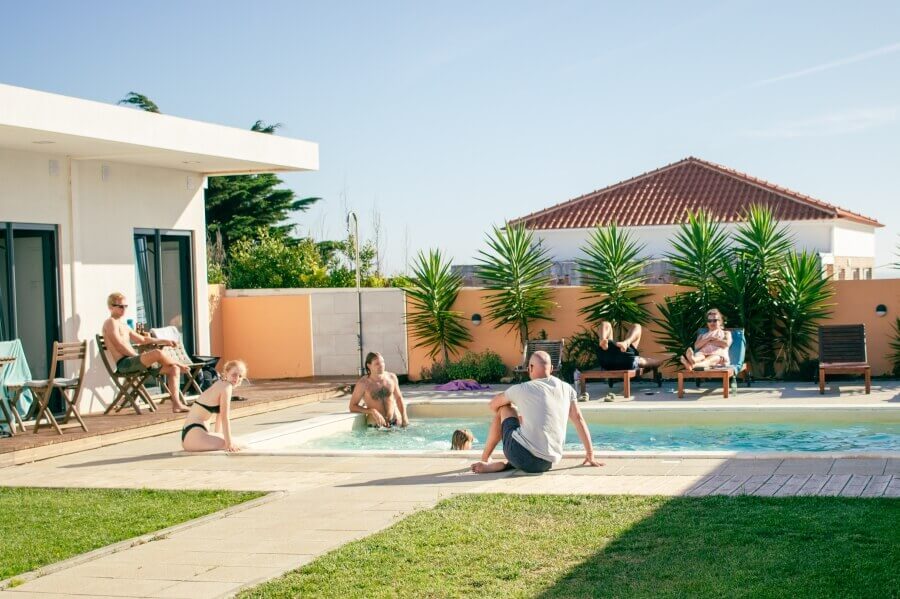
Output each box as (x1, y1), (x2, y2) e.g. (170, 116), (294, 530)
(0, 84), (319, 175)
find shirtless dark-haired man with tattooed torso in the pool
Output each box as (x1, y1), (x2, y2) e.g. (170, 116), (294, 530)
(350, 352), (409, 427)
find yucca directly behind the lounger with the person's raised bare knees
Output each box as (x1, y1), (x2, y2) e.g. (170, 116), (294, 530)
(575, 224), (650, 339)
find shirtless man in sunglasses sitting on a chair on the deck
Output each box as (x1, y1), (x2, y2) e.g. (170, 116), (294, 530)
(103, 292), (191, 412)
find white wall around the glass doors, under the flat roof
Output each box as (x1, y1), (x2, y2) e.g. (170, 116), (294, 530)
(0, 148), (209, 411)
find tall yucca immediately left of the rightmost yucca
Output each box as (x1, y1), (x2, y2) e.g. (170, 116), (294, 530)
(714, 205), (792, 375)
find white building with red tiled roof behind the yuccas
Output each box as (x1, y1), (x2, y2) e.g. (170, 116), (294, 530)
(510, 157), (883, 279)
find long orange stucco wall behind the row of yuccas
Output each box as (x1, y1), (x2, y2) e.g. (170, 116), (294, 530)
(407, 279), (900, 379)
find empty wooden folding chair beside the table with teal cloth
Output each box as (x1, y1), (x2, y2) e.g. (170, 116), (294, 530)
(26, 341), (88, 435)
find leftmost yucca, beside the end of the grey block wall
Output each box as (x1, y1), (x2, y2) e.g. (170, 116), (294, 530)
(405, 250), (472, 366)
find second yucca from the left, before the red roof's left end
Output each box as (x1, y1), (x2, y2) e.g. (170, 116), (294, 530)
(476, 225), (556, 348)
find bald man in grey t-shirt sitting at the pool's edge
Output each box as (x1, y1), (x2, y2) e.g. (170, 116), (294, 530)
(472, 351), (602, 473)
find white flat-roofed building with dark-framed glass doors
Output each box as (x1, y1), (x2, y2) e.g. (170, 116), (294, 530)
(0, 85), (319, 411)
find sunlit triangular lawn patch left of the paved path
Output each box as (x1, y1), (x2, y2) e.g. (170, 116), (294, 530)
(0, 488), (262, 580)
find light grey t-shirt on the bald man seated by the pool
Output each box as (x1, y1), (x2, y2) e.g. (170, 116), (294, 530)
(506, 376), (578, 464)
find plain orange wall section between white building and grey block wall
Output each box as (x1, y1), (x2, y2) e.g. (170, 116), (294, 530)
(219, 295), (314, 379)
